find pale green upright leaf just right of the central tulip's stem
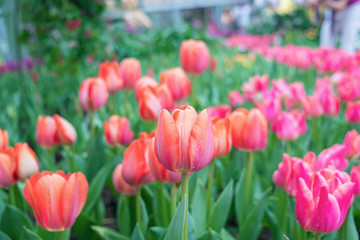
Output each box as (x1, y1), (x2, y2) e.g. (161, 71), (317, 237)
(190, 180), (206, 237)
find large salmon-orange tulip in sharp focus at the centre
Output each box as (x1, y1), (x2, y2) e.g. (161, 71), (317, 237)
(154, 106), (214, 173)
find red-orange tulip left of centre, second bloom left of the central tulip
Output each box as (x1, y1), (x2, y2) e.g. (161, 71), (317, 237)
(122, 133), (154, 187)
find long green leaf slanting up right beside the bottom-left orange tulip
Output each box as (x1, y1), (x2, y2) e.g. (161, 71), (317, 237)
(83, 162), (115, 213)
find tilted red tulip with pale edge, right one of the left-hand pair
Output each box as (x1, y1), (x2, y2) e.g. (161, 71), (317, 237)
(53, 115), (77, 145)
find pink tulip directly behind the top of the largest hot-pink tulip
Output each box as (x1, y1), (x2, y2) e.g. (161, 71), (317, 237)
(316, 144), (348, 171)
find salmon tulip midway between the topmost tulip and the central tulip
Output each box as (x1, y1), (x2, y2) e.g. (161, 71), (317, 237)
(160, 67), (191, 101)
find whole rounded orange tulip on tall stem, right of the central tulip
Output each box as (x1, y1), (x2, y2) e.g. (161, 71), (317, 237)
(230, 108), (268, 151)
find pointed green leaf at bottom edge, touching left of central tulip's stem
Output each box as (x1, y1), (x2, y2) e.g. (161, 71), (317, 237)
(165, 197), (185, 240)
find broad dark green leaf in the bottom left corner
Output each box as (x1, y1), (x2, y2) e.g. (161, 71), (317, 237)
(0, 205), (33, 240)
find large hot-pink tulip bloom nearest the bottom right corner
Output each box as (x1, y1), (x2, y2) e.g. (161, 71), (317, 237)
(295, 168), (355, 233)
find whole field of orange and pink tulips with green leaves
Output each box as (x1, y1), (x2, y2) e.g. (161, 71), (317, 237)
(0, 35), (360, 240)
